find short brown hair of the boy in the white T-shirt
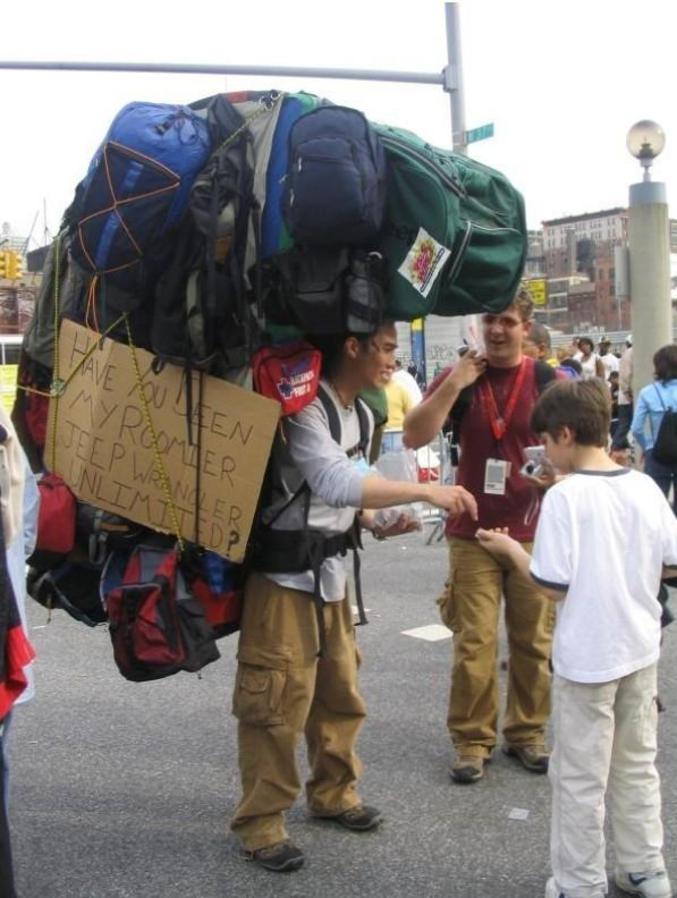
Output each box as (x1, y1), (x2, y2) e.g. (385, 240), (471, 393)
(531, 377), (611, 446)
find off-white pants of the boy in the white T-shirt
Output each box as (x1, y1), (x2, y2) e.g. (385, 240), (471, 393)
(548, 664), (664, 898)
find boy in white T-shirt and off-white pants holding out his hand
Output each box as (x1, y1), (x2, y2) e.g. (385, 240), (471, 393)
(477, 380), (677, 898)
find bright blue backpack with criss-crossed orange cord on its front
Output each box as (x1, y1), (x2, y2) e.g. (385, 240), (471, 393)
(69, 103), (211, 292)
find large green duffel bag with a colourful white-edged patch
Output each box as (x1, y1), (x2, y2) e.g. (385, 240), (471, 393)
(376, 125), (527, 321)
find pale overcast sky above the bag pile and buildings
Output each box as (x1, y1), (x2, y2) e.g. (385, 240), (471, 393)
(0, 0), (677, 239)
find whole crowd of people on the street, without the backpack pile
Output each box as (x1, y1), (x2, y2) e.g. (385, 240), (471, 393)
(0, 291), (677, 898)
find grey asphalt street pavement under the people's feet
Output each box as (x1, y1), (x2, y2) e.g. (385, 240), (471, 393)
(10, 534), (677, 898)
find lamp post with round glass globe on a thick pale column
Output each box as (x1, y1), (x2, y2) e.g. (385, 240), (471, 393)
(627, 121), (672, 396)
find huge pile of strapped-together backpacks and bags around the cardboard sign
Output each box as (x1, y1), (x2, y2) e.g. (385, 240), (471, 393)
(14, 91), (527, 680)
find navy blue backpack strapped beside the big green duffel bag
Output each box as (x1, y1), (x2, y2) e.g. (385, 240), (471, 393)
(282, 105), (386, 246)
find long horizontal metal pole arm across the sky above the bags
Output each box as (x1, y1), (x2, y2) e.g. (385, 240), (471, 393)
(0, 60), (445, 85)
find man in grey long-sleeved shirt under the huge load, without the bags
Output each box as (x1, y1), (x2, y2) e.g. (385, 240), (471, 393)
(231, 324), (477, 872)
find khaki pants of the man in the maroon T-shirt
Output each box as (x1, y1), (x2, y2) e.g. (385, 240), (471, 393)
(441, 538), (555, 757)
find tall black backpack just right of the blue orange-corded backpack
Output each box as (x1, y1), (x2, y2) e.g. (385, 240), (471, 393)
(151, 94), (260, 374)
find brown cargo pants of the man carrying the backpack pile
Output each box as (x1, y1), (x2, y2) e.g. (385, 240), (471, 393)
(231, 574), (366, 851)
